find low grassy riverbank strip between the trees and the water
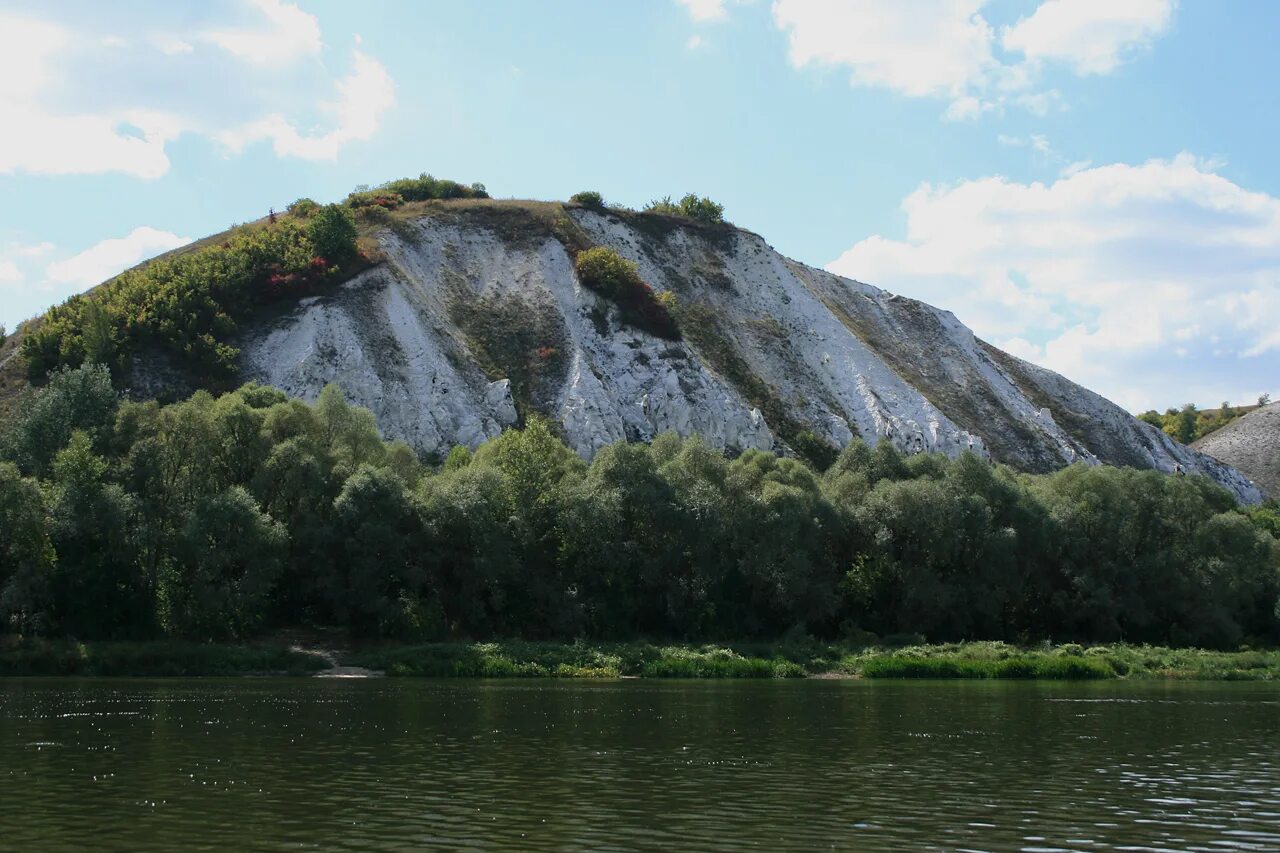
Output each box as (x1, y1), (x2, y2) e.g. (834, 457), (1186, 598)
(0, 638), (1280, 681)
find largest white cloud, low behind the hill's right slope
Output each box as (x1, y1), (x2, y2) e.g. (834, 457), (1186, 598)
(829, 154), (1280, 409)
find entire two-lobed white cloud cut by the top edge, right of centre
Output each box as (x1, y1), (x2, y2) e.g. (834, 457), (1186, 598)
(773, 0), (1172, 120)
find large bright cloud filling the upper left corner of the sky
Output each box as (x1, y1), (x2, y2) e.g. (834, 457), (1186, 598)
(0, 0), (394, 179)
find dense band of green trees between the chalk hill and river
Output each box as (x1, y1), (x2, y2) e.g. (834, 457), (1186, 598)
(0, 366), (1280, 647)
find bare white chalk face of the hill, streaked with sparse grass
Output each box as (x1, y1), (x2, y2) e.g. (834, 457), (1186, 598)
(241, 202), (1261, 502)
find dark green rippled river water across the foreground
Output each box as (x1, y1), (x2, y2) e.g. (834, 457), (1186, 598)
(0, 679), (1280, 850)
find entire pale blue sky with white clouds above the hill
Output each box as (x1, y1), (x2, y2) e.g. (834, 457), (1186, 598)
(0, 0), (1280, 411)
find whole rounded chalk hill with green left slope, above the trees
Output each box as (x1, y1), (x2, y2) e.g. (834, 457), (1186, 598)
(0, 175), (1261, 502)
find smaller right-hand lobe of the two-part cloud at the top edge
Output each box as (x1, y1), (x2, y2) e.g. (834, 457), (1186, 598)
(1001, 0), (1175, 74)
